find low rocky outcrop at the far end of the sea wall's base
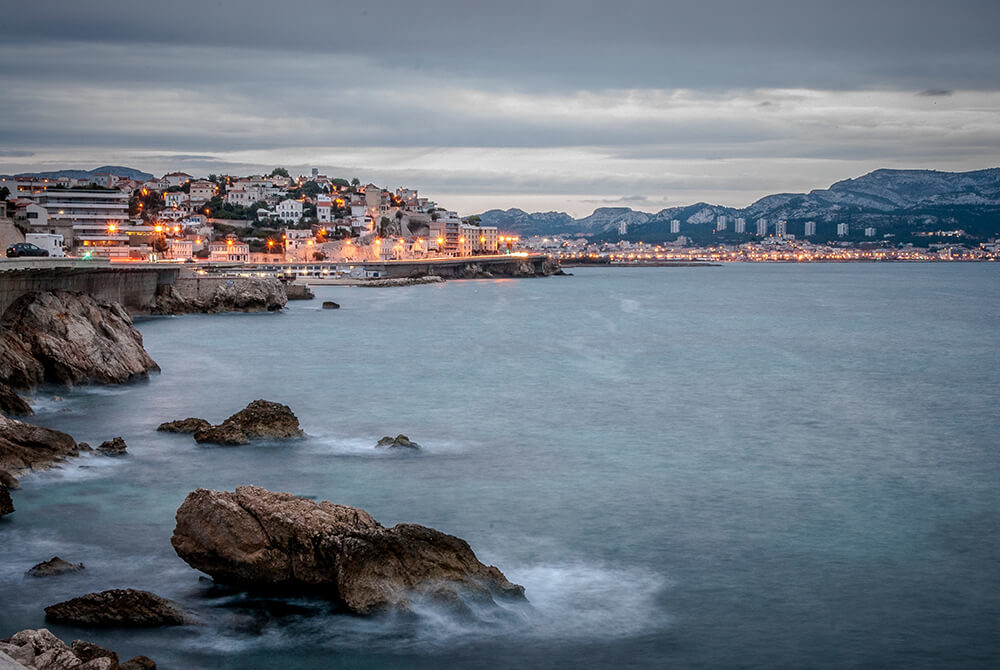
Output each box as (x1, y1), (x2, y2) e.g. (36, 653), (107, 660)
(150, 277), (288, 314)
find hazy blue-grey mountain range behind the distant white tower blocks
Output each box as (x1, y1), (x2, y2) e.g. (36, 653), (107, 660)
(481, 168), (1000, 241)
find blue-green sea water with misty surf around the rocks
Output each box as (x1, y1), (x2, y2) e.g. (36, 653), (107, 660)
(0, 265), (1000, 669)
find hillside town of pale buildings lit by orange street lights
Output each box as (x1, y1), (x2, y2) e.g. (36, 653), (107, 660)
(0, 168), (518, 264)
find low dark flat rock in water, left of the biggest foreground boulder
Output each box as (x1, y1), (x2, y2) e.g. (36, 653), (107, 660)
(45, 589), (188, 627)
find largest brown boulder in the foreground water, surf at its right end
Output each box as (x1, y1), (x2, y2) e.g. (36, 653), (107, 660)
(171, 486), (524, 613)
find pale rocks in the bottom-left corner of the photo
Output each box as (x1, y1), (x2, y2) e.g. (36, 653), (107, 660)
(0, 628), (156, 670)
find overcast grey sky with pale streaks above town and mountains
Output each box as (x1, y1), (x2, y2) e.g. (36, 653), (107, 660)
(0, 0), (1000, 216)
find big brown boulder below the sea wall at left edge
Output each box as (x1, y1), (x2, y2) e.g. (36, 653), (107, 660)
(0, 291), (159, 389)
